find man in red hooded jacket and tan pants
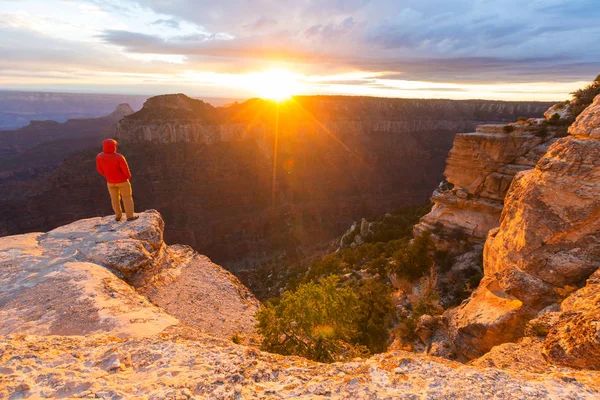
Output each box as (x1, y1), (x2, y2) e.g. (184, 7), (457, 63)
(96, 139), (139, 221)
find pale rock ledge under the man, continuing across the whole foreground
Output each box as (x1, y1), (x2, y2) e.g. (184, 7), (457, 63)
(0, 211), (600, 399)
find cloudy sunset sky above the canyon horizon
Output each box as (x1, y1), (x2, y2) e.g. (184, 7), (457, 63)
(0, 0), (600, 101)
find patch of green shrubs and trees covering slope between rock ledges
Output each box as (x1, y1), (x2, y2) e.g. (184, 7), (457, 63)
(257, 204), (476, 362)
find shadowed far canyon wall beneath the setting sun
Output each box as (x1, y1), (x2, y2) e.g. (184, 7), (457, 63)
(0, 95), (548, 276)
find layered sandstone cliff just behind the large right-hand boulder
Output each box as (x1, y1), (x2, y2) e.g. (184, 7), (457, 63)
(415, 119), (552, 247)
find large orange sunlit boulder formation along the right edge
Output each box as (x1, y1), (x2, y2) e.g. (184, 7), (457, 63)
(448, 101), (600, 360)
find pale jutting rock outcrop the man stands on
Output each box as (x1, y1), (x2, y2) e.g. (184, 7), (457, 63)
(0, 211), (258, 337)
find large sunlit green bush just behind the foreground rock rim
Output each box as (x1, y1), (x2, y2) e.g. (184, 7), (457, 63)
(256, 276), (366, 362)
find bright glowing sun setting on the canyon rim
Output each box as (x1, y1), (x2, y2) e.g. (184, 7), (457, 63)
(251, 69), (301, 102)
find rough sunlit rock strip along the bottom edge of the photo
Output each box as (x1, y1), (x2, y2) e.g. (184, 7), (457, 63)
(0, 331), (600, 400)
